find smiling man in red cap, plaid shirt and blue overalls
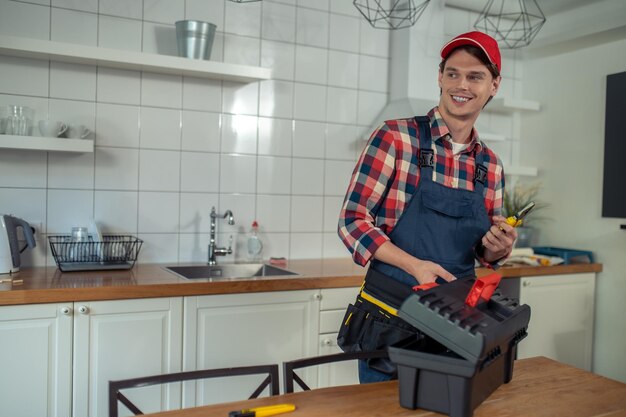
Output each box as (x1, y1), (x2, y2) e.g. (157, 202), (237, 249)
(338, 32), (517, 383)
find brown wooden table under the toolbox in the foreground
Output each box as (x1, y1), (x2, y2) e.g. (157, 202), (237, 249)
(141, 357), (626, 417)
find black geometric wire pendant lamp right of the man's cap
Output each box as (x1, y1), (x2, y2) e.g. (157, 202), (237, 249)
(474, 0), (546, 49)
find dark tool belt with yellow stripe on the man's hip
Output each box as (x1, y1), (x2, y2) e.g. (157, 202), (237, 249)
(337, 268), (421, 374)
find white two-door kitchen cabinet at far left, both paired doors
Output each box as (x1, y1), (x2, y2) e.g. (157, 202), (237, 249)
(0, 297), (182, 417)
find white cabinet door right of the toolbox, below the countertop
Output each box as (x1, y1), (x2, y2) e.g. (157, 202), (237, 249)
(518, 273), (595, 371)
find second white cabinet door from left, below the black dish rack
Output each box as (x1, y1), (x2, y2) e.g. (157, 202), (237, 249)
(74, 298), (182, 417)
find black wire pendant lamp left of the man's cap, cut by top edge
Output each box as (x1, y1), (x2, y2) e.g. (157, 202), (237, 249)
(352, 0), (430, 29)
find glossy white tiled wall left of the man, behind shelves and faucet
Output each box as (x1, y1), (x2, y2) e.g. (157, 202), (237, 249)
(0, 0), (389, 265)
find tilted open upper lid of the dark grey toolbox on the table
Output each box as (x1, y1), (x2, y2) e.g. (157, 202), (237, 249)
(398, 279), (530, 365)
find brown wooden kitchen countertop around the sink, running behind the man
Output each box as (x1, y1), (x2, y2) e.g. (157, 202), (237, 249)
(0, 258), (602, 305)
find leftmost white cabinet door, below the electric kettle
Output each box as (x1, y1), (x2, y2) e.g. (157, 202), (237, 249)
(0, 304), (72, 417)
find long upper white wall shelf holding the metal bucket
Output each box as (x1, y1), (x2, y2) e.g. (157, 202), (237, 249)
(0, 36), (272, 83)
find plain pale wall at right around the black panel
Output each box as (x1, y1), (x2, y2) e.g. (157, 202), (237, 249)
(521, 40), (626, 382)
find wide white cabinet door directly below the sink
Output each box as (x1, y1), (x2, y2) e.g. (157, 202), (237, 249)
(183, 290), (319, 407)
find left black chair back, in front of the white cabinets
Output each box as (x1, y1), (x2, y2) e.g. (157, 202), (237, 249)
(109, 365), (279, 417)
